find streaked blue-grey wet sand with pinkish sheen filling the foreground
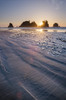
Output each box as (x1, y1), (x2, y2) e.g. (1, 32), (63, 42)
(0, 30), (66, 100)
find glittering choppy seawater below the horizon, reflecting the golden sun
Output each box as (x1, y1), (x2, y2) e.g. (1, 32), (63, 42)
(11, 28), (66, 57)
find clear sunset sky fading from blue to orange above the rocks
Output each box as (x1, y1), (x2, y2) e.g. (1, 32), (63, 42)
(0, 0), (66, 27)
